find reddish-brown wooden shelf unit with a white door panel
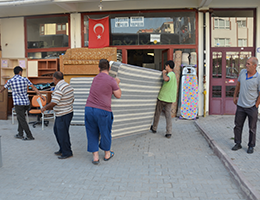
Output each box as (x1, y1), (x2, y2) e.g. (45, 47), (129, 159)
(28, 58), (59, 84)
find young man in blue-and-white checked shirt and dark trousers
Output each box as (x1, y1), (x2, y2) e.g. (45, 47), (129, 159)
(0, 66), (45, 140)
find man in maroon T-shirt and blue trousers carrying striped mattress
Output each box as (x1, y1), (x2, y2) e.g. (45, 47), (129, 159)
(85, 59), (121, 165)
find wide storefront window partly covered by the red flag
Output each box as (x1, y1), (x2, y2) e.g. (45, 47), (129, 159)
(84, 11), (196, 46)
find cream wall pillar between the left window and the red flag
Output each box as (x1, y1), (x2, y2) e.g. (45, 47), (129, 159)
(70, 13), (81, 48)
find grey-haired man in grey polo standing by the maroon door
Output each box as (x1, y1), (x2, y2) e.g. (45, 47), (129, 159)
(232, 57), (260, 154)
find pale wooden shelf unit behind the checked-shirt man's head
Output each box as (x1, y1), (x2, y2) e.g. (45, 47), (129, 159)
(1, 58), (27, 85)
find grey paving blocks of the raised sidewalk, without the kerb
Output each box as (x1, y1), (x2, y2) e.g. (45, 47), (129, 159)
(196, 115), (260, 198)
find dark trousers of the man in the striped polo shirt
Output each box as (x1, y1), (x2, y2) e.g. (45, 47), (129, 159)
(53, 112), (73, 156)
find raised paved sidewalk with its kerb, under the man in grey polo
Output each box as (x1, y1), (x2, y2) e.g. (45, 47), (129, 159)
(195, 115), (260, 199)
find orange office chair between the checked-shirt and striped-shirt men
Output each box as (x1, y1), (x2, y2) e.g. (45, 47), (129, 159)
(29, 95), (55, 130)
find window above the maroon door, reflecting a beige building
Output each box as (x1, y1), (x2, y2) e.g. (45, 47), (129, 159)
(211, 10), (255, 47)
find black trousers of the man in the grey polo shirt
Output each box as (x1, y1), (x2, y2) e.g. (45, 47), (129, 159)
(234, 106), (258, 147)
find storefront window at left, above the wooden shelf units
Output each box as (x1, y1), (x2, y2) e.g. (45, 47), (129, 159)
(25, 15), (69, 58)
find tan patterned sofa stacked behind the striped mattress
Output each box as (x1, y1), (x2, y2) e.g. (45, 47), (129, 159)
(60, 47), (117, 83)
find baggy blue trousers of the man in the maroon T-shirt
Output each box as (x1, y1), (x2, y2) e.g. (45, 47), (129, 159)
(85, 107), (114, 152)
